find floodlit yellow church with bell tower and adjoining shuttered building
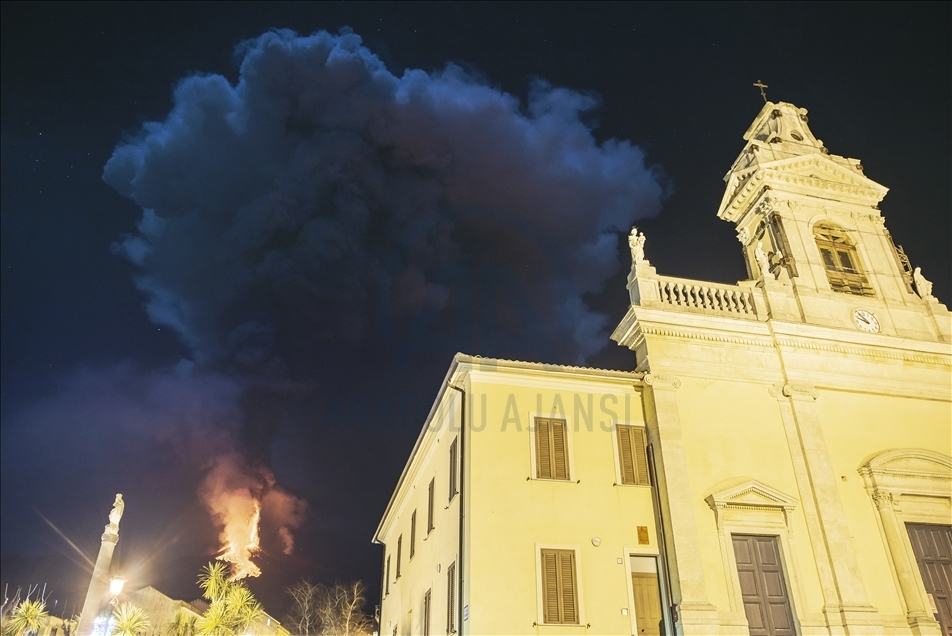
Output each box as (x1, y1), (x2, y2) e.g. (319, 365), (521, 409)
(374, 102), (952, 636)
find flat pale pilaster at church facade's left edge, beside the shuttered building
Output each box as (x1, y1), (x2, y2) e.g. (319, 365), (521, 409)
(644, 373), (720, 634)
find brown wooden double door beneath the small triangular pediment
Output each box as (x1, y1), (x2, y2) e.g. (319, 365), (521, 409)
(732, 534), (796, 636)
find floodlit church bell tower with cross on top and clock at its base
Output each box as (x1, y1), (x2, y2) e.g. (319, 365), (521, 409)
(717, 102), (952, 342)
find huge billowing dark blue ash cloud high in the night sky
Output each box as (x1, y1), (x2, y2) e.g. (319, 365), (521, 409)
(103, 31), (662, 370)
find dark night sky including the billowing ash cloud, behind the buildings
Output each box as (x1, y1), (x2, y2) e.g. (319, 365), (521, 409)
(0, 2), (952, 610)
